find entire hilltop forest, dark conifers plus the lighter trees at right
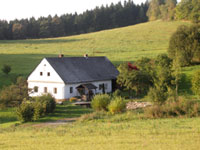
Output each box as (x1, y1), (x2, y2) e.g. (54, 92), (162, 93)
(0, 0), (200, 40)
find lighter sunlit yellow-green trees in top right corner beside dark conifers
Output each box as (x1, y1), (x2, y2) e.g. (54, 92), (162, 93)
(147, 0), (200, 23)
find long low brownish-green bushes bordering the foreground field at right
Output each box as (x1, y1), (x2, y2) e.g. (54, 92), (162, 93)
(144, 98), (200, 118)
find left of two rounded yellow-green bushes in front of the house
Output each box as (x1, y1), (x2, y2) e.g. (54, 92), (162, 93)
(91, 94), (111, 111)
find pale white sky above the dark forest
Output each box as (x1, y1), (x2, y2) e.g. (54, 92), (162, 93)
(0, 0), (146, 21)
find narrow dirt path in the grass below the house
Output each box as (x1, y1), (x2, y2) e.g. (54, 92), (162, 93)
(32, 118), (78, 127)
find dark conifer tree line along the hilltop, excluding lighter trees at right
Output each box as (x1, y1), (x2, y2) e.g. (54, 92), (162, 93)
(0, 0), (148, 40)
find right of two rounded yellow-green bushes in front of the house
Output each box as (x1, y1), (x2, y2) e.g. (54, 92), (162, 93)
(108, 97), (126, 114)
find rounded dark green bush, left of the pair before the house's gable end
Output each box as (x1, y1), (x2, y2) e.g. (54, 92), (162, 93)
(16, 101), (34, 123)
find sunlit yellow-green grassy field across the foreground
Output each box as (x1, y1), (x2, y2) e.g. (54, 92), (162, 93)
(0, 106), (200, 150)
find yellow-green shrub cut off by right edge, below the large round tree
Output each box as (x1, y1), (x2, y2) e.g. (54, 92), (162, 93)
(192, 70), (200, 97)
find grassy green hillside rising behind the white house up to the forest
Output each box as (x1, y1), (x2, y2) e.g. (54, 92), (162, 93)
(0, 21), (194, 87)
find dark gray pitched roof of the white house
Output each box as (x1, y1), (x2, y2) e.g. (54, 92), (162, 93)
(46, 57), (119, 84)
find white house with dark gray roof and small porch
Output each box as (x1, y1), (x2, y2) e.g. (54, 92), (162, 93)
(28, 56), (119, 100)
